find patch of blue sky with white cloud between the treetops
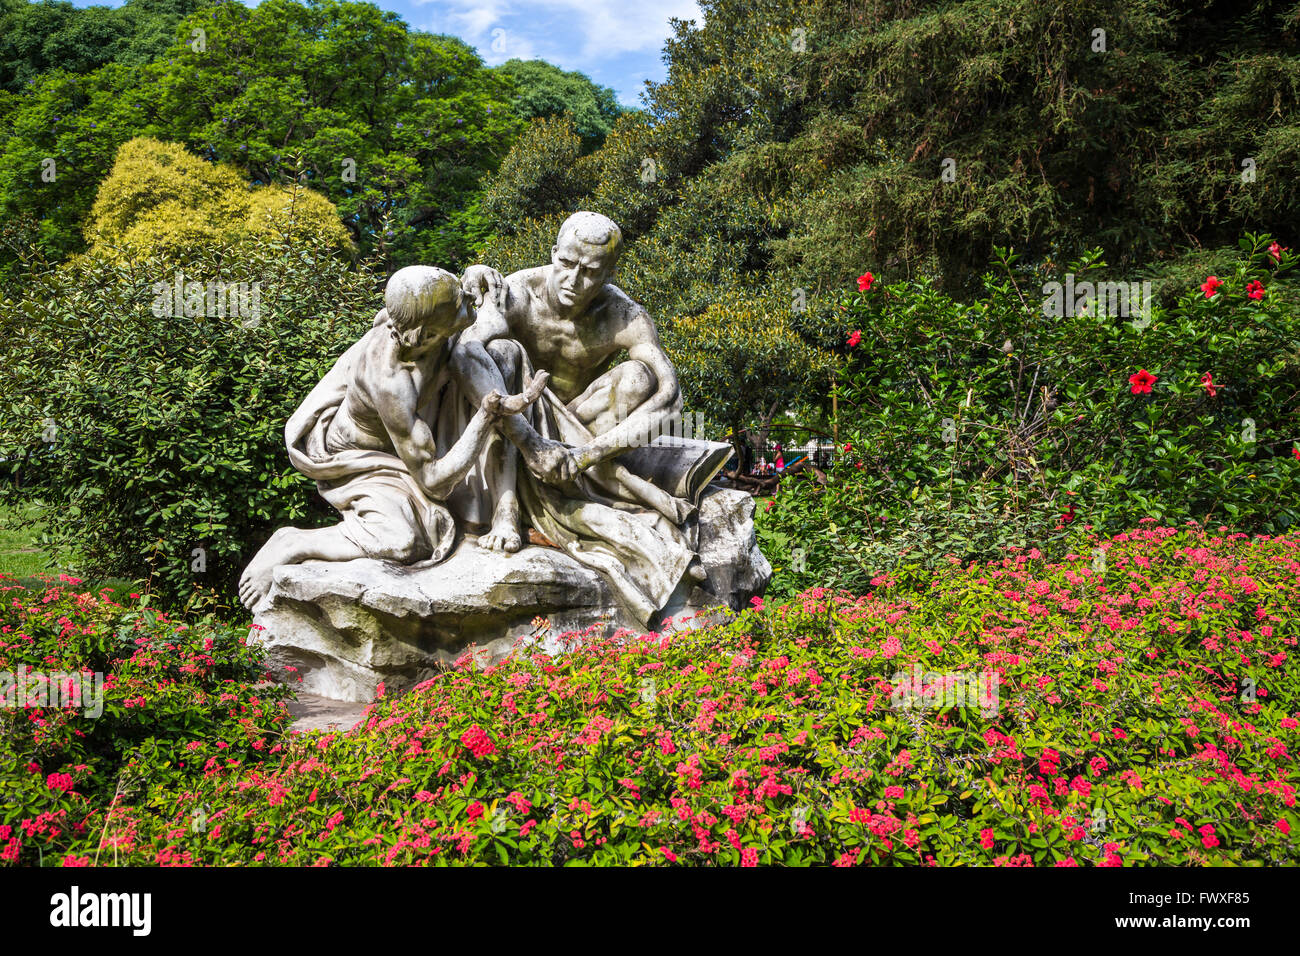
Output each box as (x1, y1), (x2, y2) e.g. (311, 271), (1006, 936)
(65, 0), (702, 107)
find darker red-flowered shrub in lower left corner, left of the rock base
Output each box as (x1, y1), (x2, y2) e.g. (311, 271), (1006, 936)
(0, 575), (287, 864)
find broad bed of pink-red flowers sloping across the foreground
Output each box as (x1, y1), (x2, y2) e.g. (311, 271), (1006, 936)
(5, 523), (1300, 865)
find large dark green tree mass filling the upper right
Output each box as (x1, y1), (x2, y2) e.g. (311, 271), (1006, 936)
(482, 0), (1300, 429)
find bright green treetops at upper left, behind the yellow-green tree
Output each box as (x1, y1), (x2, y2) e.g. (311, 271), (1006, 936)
(0, 0), (506, 267)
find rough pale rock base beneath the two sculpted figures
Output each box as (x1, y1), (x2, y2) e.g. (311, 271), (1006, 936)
(254, 485), (772, 701)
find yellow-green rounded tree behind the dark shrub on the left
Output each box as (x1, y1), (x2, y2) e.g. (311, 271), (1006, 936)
(86, 137), (351, 261)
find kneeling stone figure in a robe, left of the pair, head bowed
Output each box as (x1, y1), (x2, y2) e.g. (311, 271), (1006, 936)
(239, 265), (546, 609)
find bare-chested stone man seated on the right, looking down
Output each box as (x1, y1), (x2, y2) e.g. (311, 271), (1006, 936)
(451, 212), (681, 550)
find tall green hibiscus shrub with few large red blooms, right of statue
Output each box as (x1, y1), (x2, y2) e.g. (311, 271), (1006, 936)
(758, 235), (1300, 598)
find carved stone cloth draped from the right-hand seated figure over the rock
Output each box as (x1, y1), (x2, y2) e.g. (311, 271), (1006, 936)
(438, 349), (725, 626)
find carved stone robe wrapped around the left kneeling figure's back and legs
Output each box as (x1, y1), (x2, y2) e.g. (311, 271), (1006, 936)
(285, 330), (456, 567)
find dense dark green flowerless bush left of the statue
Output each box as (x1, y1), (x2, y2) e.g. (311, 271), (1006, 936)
(0, 230), (382, 601)
